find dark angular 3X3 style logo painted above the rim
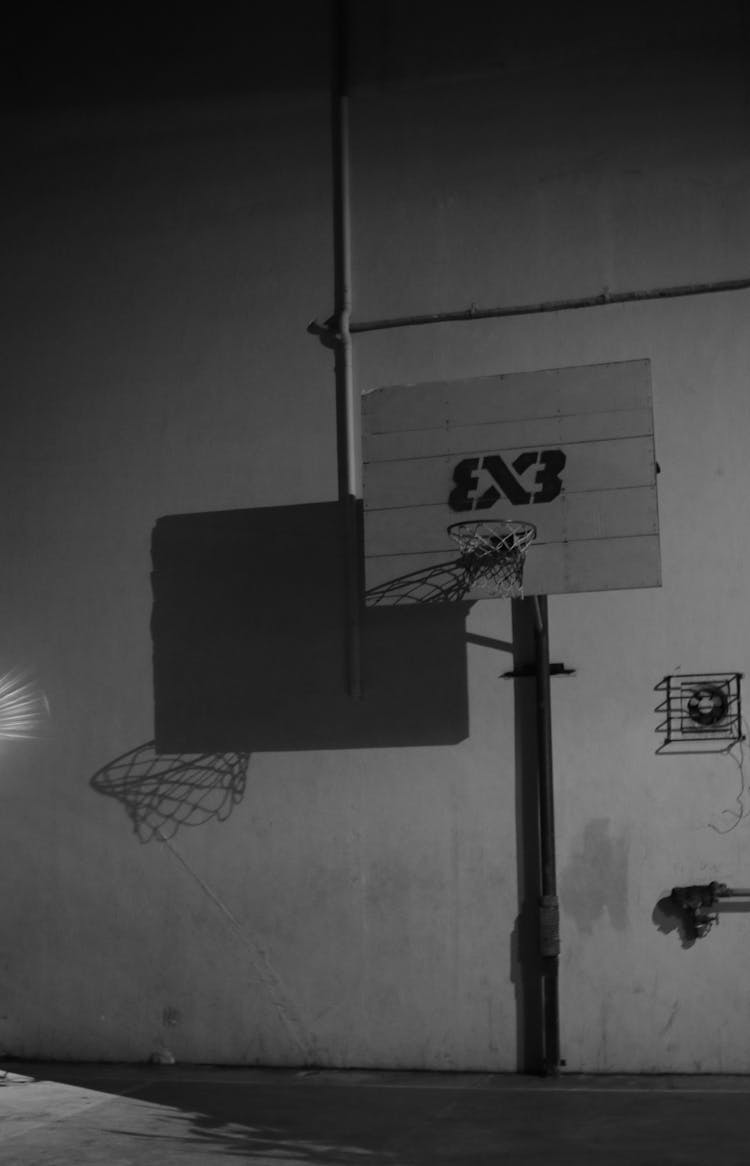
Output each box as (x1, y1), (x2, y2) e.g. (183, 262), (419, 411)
(448, 449), (567, 511)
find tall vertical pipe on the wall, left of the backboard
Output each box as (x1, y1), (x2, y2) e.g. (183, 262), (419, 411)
(331, 0), (362, 697)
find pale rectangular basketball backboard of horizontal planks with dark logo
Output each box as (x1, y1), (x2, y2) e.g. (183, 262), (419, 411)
(363, 360), (661, 603)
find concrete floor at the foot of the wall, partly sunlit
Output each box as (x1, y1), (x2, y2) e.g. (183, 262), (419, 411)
(0, 1062), (750, 1166)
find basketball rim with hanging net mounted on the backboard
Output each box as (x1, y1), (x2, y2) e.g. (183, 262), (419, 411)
(448, 519), (537, 599)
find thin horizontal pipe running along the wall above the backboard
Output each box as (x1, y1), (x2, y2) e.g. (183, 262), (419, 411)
(349, 271), (750, 332)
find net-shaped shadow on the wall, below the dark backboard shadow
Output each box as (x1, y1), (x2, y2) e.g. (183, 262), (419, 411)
(90, 740), (250, 842)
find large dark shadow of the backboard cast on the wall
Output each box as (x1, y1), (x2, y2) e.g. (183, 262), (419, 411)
(152, 503), (469, 753)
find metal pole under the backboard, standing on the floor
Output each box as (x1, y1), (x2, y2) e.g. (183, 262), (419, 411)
(534, 596), (560, 1076)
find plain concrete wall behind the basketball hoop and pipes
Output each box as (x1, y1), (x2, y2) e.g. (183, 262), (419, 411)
(0, 9), (750, 1072)
